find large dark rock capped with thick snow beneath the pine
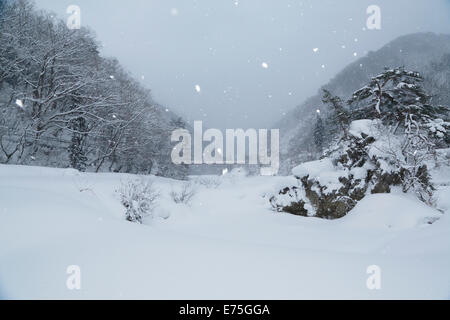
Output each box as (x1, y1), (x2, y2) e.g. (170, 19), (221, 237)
(270, 120), (432, 219)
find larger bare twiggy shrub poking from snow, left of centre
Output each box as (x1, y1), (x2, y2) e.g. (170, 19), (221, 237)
(118, 179), (160, 223)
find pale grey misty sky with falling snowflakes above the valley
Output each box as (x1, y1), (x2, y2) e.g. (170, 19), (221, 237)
(36, 0), (450, 128)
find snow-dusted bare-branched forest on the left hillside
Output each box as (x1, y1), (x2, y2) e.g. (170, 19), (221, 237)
(0, 0), (187, 178)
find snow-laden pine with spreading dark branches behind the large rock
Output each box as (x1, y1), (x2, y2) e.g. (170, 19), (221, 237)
(348, 68), (450, 201)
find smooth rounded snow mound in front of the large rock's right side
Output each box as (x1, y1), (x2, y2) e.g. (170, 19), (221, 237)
(341, 194), (442, 230)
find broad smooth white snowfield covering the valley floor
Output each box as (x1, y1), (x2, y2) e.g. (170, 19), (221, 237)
(0, 166), (450, 299)
